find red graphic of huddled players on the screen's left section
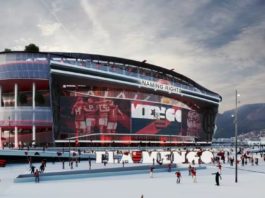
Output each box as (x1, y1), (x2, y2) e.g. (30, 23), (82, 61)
(60, 96), (130, 136)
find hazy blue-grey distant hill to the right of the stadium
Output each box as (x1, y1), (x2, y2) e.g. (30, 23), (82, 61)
(214, 103), (265, 138)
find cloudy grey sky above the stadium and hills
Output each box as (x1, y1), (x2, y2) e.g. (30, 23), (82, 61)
(0, 0), (265, 112)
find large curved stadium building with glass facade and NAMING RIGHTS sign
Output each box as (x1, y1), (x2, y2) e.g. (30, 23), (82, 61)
(0, 51), (221, 147)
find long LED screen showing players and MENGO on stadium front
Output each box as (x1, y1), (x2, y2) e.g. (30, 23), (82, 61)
(57, 93), (203, 138)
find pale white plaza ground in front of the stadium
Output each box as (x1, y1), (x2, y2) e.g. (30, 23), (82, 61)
(0, 154), (265, 198)
